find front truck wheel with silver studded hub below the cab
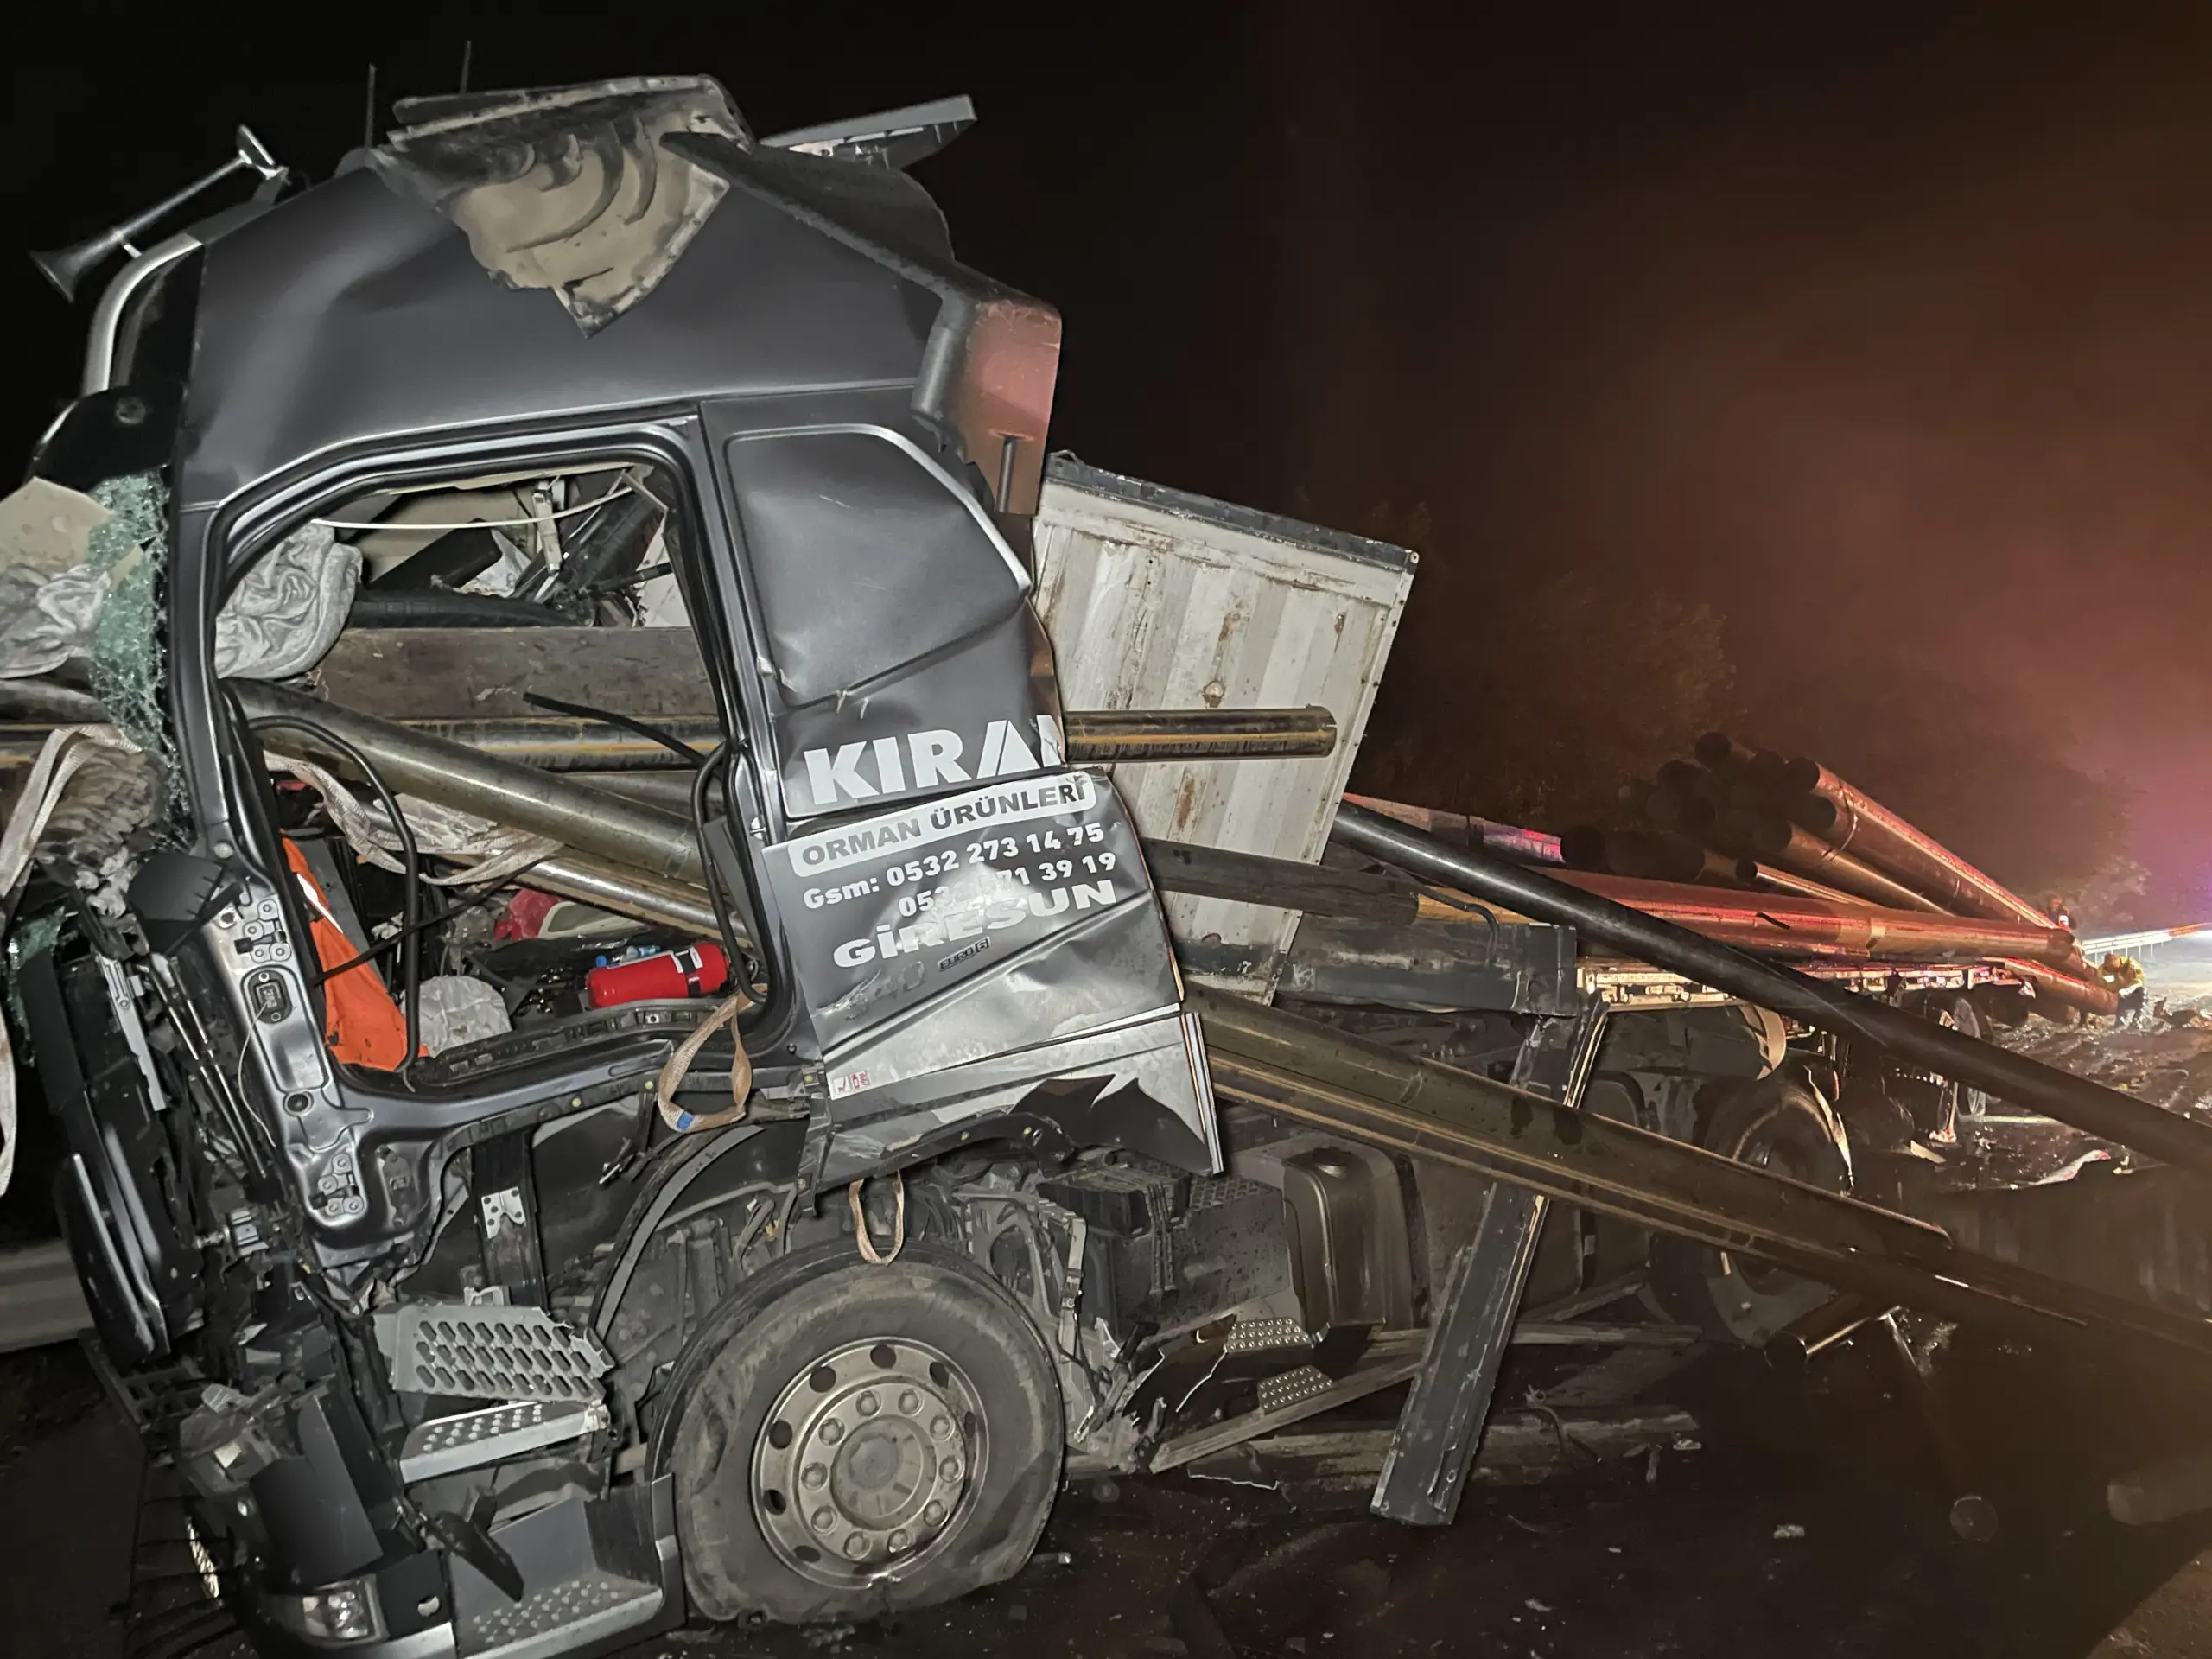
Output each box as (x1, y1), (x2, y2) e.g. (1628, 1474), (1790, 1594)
(664, 1245), (1064, 1624)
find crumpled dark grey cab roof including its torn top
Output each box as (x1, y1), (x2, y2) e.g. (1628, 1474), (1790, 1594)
(177, 82), (951, 511)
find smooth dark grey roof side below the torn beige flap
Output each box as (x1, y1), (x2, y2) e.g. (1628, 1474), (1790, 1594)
(177, 162), (929, 512)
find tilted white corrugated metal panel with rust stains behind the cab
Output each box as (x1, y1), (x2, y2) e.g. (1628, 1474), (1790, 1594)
(1035, 455), (1418, 998)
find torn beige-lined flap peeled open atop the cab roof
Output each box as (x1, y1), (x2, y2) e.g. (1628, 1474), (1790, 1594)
(370, 75), (750, 334)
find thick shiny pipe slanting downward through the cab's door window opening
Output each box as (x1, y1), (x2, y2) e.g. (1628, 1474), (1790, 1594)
(230, 679), (703, 885)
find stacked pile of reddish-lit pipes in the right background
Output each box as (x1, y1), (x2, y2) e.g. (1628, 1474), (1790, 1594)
(1560, 732), (2117, 1013)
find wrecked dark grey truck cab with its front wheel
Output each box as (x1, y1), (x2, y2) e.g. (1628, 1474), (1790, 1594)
(11, 82), (1234, 1656)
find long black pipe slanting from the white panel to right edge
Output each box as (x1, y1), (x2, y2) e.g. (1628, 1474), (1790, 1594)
(1334, 807), (2212, 1177)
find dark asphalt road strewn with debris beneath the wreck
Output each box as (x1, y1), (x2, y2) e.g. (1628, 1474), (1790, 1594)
(0, 1338), (2212, 1659)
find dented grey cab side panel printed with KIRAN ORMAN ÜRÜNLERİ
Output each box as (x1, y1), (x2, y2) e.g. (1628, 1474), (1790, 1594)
(706, 390), (1212, 1164)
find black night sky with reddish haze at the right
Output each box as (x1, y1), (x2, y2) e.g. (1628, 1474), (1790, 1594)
(4, 3), (2212, 920)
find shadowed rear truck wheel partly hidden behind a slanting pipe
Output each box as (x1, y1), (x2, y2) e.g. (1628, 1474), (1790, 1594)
(1650, 1073), (1852, 1347)
